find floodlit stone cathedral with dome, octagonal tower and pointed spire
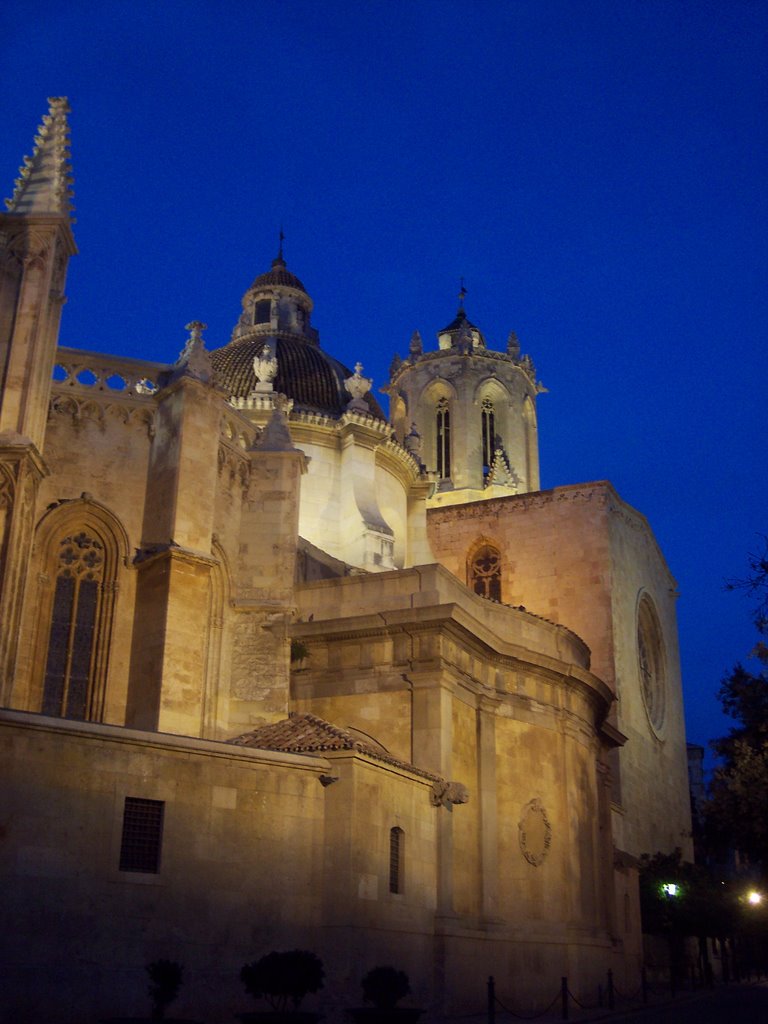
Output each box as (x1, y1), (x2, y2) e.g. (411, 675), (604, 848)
(0, 98), (690, 1024)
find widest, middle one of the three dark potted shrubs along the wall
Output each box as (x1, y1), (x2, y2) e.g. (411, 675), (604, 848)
(238, 949), (326, 1024)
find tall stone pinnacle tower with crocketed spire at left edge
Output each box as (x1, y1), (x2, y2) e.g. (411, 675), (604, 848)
(0, 98), (77, 702)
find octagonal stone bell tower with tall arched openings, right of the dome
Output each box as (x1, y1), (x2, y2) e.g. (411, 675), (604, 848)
(384, 282), (546, 505)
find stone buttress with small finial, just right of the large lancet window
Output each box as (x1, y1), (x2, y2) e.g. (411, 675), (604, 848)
(126, 331), (221, 736)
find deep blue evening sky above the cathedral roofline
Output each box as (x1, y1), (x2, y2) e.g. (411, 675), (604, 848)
(0, 0), (768, 742)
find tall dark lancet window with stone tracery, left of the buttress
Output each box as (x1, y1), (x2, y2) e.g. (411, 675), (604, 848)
(42, 529), (114, 719)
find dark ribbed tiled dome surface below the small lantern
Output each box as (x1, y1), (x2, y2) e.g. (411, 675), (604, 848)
(211, 333), (386, 421)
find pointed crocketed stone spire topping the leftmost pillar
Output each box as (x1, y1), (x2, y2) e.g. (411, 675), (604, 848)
(5, 96), (74, 220)
